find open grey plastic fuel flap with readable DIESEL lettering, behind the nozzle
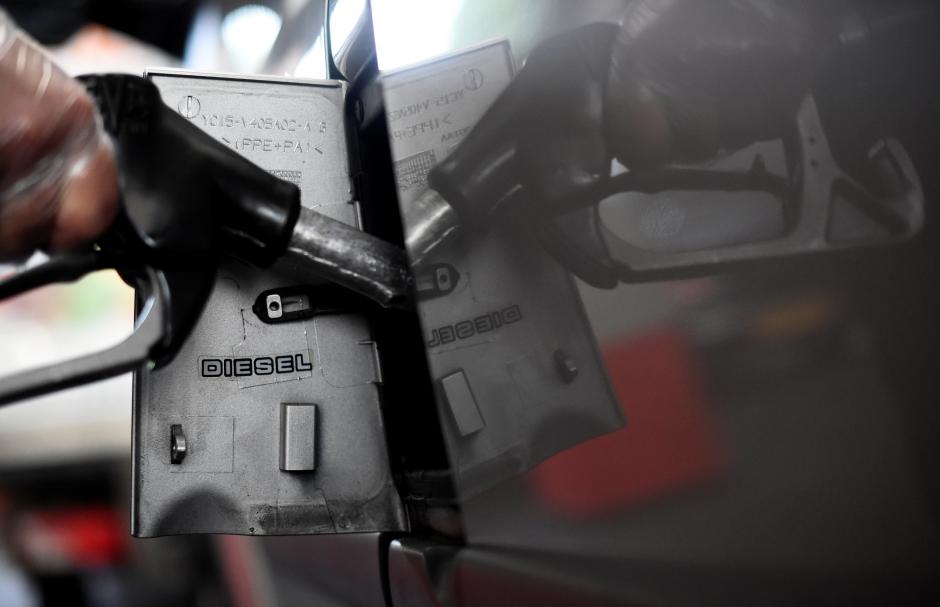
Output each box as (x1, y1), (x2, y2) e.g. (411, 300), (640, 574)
(132, 72), (406, 537)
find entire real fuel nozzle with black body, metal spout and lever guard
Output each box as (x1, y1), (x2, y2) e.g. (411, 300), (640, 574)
(0, 75), (411, 405)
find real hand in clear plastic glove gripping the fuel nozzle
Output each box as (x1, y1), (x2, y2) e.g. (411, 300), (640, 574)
(0, 10), (118, 259)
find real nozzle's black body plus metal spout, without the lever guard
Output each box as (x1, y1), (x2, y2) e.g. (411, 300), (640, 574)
(82, 74), (411, 307)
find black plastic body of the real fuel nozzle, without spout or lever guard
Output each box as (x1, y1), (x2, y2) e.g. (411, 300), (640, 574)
(82, 74), (300, 266)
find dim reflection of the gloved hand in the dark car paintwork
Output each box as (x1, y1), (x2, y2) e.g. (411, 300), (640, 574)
(605, 0), (815, 167)
